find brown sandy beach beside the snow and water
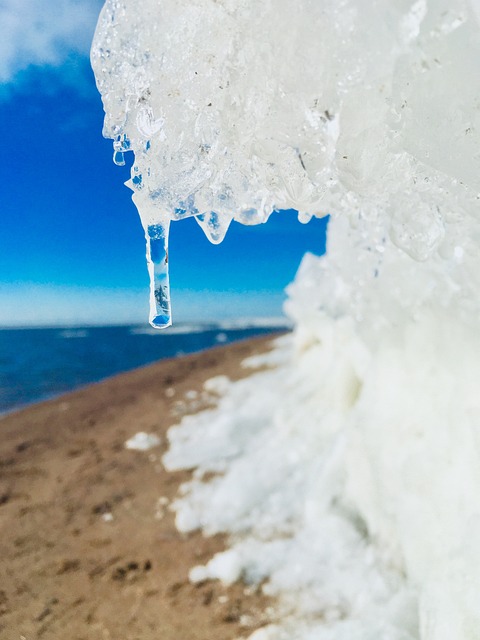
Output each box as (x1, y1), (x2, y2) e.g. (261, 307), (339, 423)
(0, 337), (282, 640)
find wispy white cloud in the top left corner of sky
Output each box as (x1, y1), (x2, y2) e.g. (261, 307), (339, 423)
(0, 0), (103, 84)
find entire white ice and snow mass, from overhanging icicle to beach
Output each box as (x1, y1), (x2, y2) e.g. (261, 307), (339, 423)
(92, 0), (480, 640)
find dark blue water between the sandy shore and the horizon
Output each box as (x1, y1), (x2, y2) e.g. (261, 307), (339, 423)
(0, 325), (284, 413)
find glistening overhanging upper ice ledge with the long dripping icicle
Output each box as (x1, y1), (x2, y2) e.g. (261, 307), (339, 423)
(92, 0), (480, 325)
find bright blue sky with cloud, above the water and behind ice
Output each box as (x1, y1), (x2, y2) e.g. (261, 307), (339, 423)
(0, 0), (325, 326)
